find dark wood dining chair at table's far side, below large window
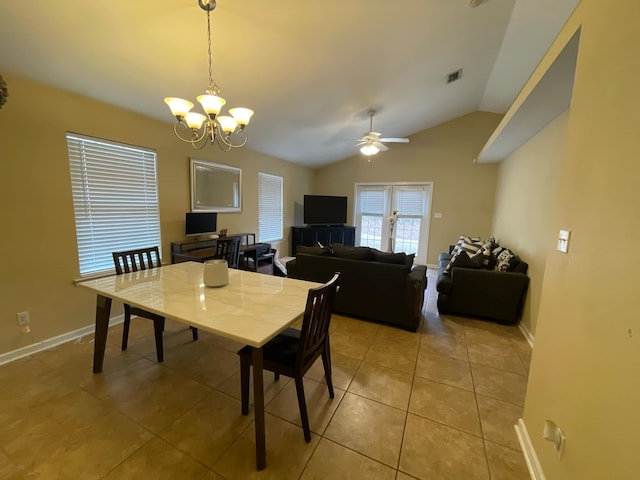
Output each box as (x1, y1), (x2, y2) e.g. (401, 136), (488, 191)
(112, 247), (198, 363)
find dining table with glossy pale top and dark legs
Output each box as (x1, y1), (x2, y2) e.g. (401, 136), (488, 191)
(79, 262), (318, 470)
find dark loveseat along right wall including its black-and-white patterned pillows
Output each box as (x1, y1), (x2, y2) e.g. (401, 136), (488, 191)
(436, 237), (529, 325)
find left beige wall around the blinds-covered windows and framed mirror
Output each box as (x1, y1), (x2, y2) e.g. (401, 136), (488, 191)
(0, 72), (313, 353)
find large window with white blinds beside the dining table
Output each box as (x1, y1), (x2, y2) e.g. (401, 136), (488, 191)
(67, 133), (160, 276)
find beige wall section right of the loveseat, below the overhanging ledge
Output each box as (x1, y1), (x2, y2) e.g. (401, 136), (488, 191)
(492, 112), (569, 335)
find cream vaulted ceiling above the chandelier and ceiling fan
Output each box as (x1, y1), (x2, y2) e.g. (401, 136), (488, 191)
(0, 0), (579, 167)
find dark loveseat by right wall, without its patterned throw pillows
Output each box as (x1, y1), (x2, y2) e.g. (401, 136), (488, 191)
(436, 242), (529, 325)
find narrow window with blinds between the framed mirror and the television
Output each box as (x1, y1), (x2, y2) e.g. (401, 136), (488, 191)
(258, 173), (282, 242)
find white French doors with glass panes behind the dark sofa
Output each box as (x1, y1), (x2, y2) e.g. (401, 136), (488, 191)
(354, 183), (432, 264)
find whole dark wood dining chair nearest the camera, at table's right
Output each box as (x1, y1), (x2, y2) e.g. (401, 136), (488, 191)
(238, 273), (340, 442)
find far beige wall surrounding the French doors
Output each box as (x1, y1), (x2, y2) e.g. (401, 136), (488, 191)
(314, 112), (502, 264)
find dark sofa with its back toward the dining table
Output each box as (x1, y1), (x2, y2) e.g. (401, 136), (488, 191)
(287, 245), (427, 331)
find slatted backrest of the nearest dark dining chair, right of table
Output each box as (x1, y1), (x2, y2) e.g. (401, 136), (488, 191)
(296, 273), (340, 366)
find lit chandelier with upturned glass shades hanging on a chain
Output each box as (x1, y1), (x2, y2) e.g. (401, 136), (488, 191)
(164, 0), (253, 152)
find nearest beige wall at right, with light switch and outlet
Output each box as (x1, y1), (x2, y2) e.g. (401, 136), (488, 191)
(524, 0), (640, 480)
